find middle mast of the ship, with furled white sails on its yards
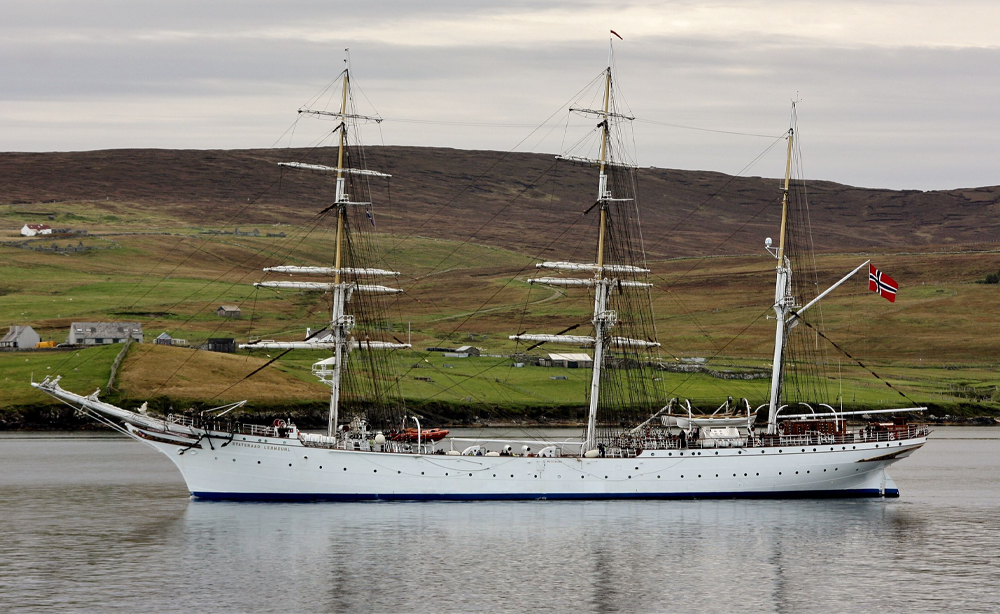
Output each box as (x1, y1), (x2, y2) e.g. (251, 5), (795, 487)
(510, 50), (660, 455)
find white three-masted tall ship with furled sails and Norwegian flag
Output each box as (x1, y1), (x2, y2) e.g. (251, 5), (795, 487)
(32, 47), (928, 501)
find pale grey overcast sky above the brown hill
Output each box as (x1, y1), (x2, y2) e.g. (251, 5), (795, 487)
(0, 0), (1000, 189)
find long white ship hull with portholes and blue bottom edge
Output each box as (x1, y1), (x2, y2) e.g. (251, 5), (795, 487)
(130, 427), (926, 501)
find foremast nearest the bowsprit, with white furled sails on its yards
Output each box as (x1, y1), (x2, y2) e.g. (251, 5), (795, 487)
(240, 68), (410, 437)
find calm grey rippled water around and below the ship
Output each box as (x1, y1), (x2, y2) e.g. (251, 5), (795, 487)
(0, 428), (1000, 613)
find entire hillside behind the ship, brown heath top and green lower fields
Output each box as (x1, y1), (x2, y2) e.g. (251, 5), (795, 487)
(0, 148), (1000, 424)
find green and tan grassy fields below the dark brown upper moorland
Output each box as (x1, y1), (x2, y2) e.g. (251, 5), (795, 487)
(0, 203), (1000, 420)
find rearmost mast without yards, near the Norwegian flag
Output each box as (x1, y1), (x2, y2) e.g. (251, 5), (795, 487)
(767, 116), (795, 435)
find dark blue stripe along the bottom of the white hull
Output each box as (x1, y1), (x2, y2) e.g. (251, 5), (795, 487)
(191, 488), (899, 501)
